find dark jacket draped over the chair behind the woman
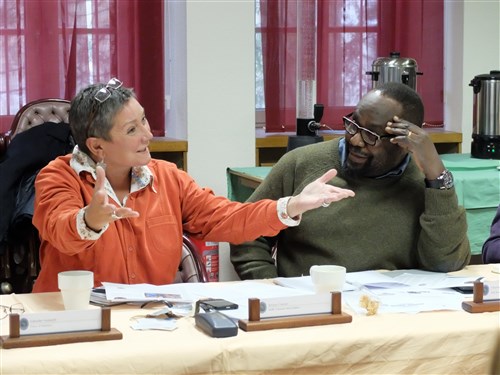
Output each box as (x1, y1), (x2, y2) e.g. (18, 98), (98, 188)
(0, 122), (74, 293)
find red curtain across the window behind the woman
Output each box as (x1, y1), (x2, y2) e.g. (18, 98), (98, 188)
(0, 0), (165, 136)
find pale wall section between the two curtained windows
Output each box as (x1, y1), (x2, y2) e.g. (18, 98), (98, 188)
(179, 0), (255, 280)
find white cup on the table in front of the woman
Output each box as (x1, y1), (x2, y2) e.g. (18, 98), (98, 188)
(57, 270), (94, 310)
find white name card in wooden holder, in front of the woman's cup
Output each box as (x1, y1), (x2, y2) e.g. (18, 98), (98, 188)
(19, 307), (102, 336)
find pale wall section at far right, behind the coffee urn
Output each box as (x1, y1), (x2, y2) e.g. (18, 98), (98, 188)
(444, 0), (500, 153)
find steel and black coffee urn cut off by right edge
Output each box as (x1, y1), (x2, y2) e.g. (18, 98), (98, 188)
(469, 70), (500, 159)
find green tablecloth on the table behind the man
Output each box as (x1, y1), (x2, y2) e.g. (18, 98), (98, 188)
(227, 154), (500, 254)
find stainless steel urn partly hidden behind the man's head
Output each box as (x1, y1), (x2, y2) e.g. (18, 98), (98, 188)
(366, 52), (423, 91)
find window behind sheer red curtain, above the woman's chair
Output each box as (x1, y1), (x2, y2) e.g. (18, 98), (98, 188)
(0, 0), (116, 131)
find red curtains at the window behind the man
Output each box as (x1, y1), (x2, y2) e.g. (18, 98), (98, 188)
(260, 0), (444, 132)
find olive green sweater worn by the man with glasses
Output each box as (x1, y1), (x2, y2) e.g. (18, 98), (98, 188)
(231, 139), (470, 279)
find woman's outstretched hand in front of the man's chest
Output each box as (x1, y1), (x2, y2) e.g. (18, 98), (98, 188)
(287, 169), (354, 217)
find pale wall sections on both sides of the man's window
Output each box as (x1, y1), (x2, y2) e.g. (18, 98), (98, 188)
(172, 0), (500, 280)
